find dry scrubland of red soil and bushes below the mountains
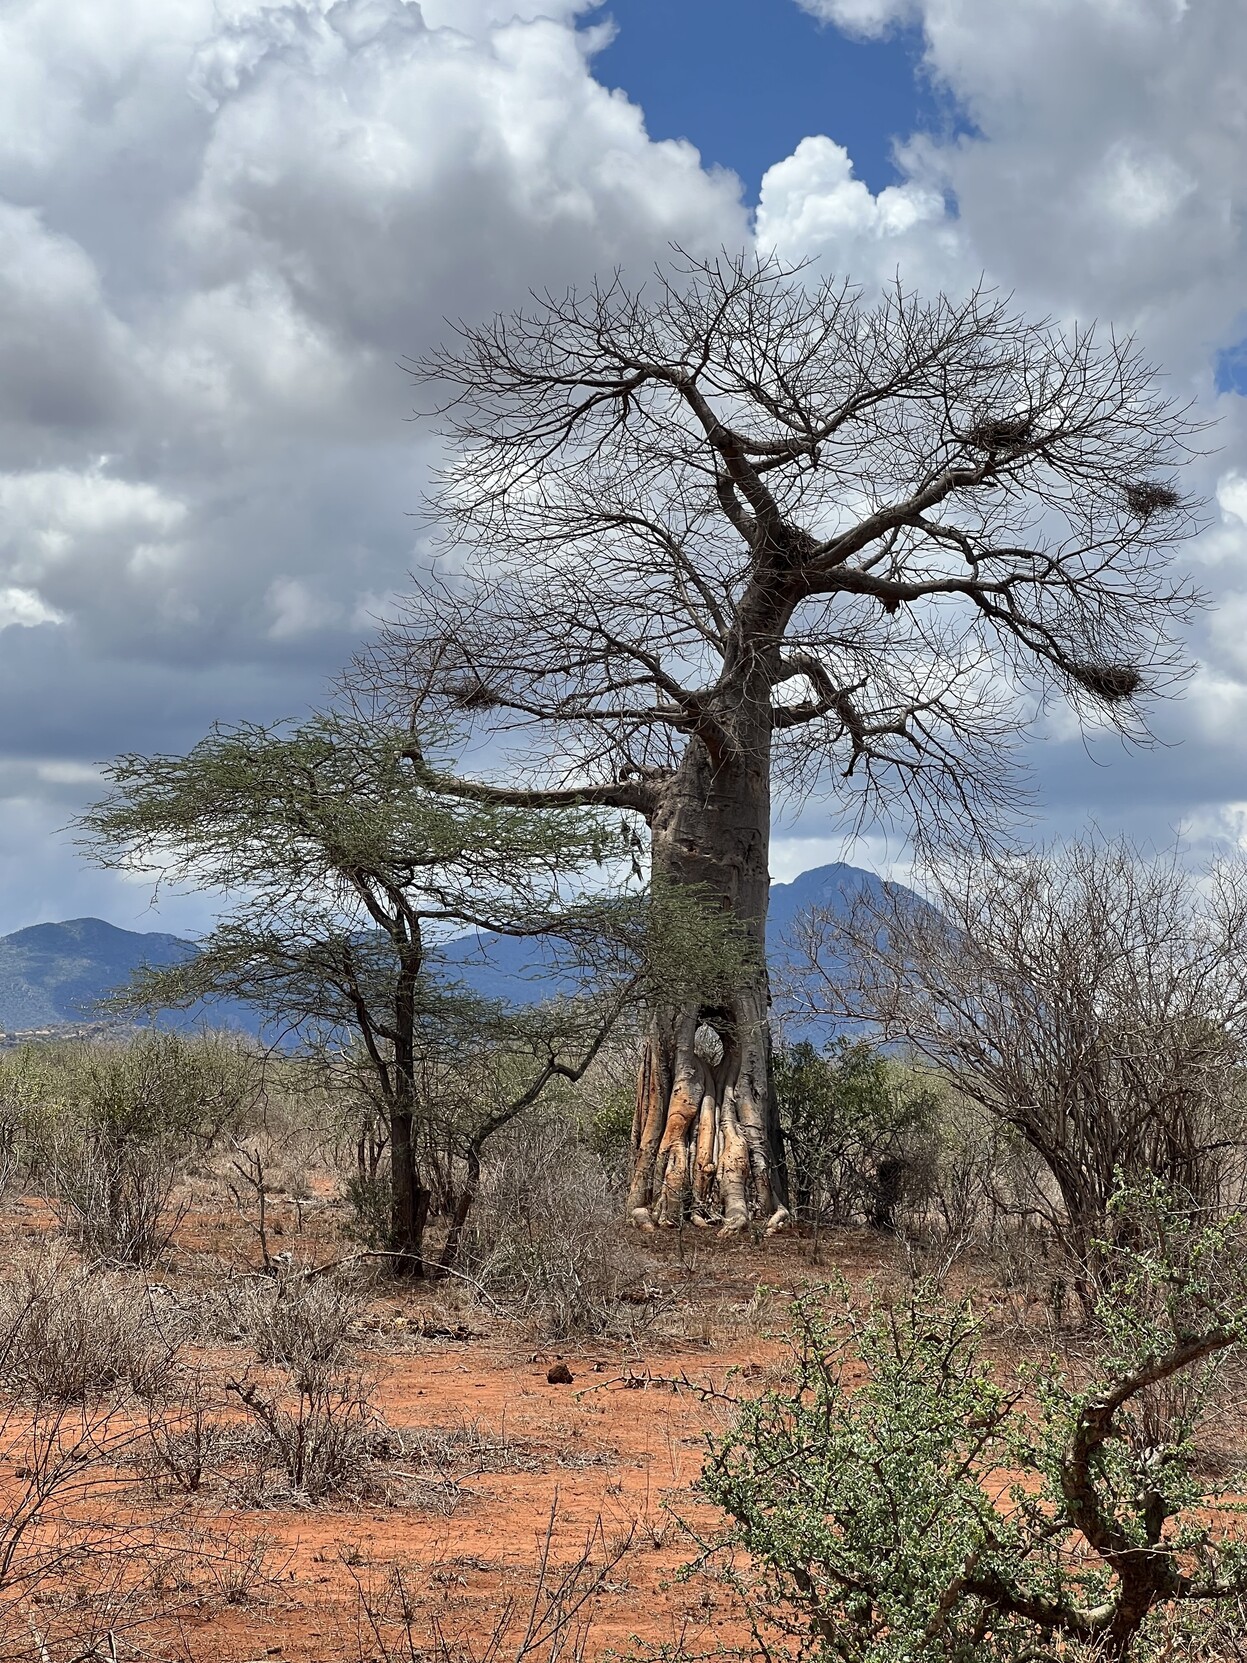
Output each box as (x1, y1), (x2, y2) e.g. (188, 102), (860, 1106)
(0, 911), (1247, 1660)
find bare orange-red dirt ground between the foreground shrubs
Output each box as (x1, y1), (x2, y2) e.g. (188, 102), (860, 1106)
(9, 1187), (1247, 1663)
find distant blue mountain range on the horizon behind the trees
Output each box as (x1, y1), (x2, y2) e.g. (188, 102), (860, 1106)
(0, 863), (904, 1033)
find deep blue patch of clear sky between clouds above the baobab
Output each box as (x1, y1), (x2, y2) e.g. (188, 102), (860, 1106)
(587, 0), (954, 203)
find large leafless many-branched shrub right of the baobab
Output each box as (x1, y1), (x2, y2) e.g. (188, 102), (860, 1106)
(798, 838), (1247, 1307)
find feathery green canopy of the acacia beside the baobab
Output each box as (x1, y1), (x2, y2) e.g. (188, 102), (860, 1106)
(80, 713), (645, 1037)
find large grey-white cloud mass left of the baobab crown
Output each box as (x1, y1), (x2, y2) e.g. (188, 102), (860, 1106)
(0, 0), (748, 928)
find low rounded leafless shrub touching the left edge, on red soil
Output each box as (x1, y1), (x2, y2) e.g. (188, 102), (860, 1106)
(0, 1254), (183, 1404)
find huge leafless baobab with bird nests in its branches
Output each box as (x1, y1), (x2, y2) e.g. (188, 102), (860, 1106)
(372, 256), (1195, 1229)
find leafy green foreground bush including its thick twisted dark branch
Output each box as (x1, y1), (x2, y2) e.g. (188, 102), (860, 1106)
(690, 1197), (1247, 1663)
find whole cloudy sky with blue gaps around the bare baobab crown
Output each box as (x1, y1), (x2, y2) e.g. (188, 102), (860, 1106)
(0, 0), (1247, 931)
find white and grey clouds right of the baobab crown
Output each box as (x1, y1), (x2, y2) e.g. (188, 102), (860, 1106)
(758, 0), (1247, 878)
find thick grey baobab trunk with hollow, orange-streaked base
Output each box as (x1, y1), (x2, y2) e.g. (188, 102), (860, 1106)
(628, 710), (788, 1232)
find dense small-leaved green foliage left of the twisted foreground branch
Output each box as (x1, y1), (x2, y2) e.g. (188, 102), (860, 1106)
(702, 1300), (1014, 1663)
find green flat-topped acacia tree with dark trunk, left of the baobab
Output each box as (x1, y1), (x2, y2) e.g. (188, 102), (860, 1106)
(78, 713), (704, 1276)
